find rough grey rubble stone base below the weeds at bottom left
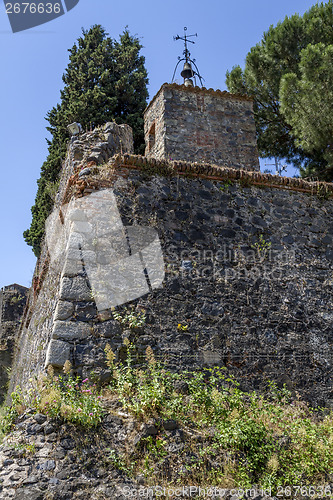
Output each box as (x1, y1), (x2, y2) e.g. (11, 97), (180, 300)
(0, 410), (288, 500)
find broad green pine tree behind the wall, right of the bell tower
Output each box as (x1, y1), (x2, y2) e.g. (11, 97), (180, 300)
(226, 0), (333, 180)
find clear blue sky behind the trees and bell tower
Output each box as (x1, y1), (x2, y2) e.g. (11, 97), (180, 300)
(0, 0), (315, 287)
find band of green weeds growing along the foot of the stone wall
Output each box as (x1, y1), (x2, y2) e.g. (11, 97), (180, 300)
(1, 339), (333, 492)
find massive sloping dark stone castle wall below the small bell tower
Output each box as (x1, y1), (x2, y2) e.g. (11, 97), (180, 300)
(11, 127), (333, 406)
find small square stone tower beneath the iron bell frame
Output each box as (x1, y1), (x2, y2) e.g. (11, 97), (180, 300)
(145, 83), (259, 171)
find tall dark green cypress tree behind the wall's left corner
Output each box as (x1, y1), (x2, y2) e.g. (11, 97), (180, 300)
(24, 25), (148, 256)
